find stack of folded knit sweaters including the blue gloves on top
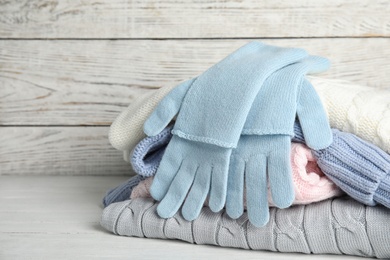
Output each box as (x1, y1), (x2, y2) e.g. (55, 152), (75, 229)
(101, 42), (390, 258)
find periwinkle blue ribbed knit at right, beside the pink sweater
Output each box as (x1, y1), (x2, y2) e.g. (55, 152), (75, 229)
(293, 122), (390, 208)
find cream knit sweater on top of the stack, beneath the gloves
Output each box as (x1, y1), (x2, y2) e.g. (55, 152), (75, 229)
(109, 77), (390, 161)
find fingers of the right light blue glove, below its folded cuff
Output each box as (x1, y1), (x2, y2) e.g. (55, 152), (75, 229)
(226, 135), (295, 224)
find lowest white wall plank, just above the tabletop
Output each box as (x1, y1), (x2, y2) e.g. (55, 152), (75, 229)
(0, 127), (133, 175)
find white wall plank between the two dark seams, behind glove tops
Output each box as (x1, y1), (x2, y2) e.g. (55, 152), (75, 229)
(0, 38), (390, 125)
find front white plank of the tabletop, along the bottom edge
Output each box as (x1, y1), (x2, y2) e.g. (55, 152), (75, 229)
(0, 233), (362, 260)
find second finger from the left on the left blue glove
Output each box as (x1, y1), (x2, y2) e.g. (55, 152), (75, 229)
(157, 160), (198, 218)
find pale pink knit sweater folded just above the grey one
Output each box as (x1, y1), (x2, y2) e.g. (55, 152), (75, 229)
(130, 143), (342, 207)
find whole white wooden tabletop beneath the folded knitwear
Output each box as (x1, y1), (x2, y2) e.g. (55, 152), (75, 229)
(0, 176), (361, 260)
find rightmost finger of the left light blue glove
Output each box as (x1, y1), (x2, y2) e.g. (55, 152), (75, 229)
(209, 161), (229, 212)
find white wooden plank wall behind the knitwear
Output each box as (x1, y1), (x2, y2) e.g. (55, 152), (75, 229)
(0, 0), (390, 175)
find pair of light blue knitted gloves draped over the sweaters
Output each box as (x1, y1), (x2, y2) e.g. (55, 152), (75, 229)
(144, 42), (332, 226)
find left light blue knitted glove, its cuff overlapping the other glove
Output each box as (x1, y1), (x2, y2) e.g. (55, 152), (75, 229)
(144, 42), (307, 220)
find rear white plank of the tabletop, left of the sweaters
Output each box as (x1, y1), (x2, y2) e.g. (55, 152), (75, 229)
(0, 176), (129, 234)
